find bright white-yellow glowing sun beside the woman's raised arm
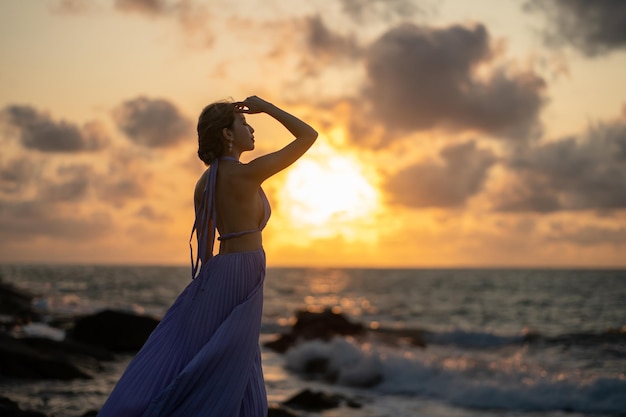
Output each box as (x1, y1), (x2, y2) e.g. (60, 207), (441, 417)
(281, 153), (378, 226)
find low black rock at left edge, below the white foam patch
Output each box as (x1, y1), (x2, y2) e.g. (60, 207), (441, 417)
(0, 333), (100, 380)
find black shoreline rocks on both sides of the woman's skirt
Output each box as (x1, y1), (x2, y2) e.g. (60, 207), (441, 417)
(0, 279), (424, 417)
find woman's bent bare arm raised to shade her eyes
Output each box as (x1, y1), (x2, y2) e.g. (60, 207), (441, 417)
(235, 96), (317, 184)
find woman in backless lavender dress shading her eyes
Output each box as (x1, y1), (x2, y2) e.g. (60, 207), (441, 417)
(98, 96), (317, 417)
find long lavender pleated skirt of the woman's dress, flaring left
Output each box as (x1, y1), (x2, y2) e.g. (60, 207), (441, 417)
(98, 249), (267, 417)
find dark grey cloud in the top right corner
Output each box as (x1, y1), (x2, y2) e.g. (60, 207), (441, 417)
(524, 0), (626, 57)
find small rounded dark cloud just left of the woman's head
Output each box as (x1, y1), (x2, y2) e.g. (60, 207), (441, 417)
(113, 97), (193, 147)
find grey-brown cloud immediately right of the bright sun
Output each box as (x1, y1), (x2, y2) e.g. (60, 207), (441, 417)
(383, 141), (496, 207)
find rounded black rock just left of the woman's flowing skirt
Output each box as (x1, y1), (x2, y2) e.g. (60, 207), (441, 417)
(68, 310), (159, 352)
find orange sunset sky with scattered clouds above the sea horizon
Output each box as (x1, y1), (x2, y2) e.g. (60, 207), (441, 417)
(0, 0), (626, 268)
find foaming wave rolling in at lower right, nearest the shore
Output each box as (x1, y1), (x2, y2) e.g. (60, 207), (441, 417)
(285, 337), (626, 414)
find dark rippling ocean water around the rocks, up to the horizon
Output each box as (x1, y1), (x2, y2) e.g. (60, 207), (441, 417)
(0, 265), (626, 417)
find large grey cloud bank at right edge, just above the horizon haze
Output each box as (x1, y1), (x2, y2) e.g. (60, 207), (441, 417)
(495, 115), (626, 212)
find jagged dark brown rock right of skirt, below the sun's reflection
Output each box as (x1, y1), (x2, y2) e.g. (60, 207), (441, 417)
(265, 308), (365, 353)
